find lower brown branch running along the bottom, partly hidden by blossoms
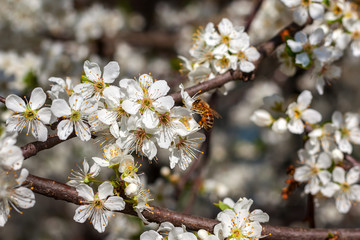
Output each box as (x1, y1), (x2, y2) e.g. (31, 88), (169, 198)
(24, 175), (360, 240)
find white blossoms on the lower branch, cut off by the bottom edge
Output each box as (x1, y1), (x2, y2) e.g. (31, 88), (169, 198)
(140, 198), (269, 240)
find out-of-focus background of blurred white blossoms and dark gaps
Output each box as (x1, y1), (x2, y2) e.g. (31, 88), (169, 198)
(0, 0), (360, 240)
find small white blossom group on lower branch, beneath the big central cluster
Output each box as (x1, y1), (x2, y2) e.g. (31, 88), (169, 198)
(67, 144), (150, 232)
